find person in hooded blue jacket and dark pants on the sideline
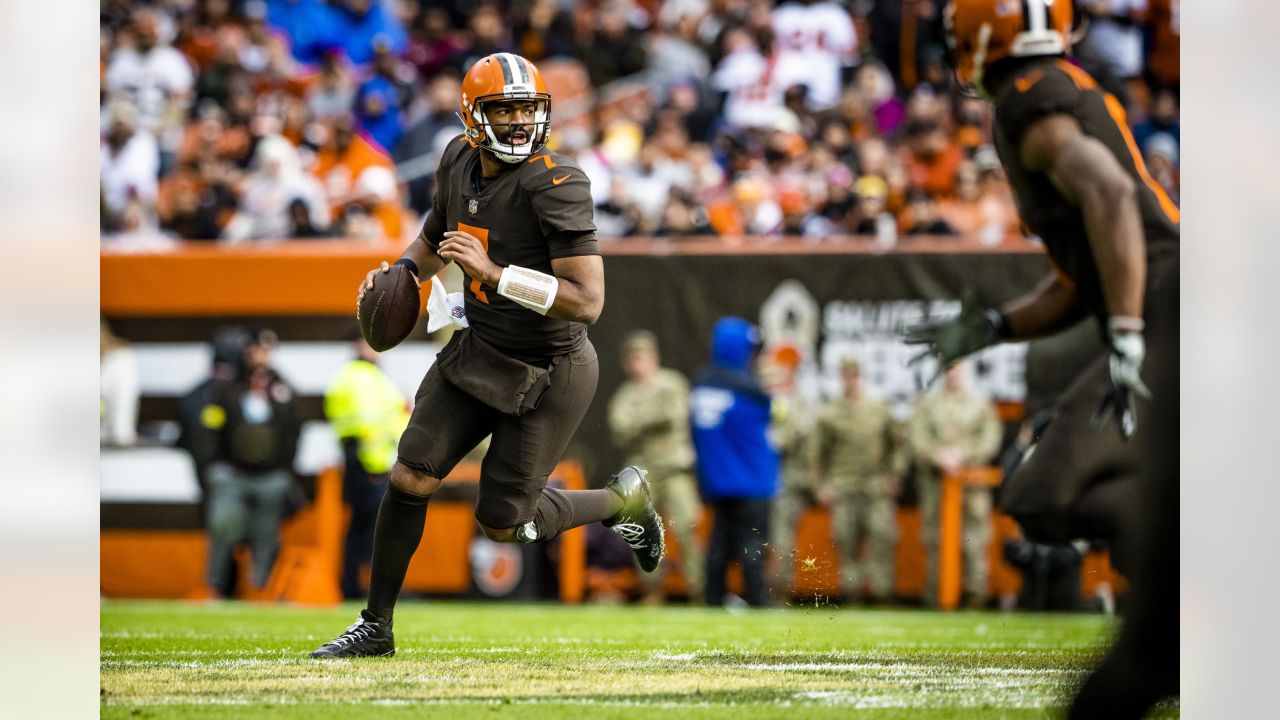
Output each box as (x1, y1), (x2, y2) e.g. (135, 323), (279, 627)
(690, 318), (778, 606)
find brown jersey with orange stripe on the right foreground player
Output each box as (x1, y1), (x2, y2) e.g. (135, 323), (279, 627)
(995, 60), (1179, 318)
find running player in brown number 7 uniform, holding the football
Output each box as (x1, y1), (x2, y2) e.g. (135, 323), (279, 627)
(311, 53), (663, 657)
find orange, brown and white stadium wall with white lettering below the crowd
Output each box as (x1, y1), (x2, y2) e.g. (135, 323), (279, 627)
(101, 238), (1121, 594)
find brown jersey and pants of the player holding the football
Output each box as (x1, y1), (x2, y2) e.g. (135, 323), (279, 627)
(398, 136), (599, 528)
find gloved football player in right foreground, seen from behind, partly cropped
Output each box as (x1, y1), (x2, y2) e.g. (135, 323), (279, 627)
(905, 0), (1179, 717)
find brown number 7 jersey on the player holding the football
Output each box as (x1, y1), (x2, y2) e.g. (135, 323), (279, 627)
(422, 136), (600, 365)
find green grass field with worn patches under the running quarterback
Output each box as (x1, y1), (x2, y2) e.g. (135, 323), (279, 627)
(101, 601), (1178, 720)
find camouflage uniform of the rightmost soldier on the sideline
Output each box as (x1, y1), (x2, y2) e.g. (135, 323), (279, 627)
(909, 389), (1001, 605)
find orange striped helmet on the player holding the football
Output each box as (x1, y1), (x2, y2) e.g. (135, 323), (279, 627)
(458, 53), (552, 163)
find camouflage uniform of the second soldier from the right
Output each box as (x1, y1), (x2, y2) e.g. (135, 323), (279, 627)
(812, 397), (906, 601)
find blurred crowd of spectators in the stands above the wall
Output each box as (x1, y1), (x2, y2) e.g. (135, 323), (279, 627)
(100, 0), (1180, 245)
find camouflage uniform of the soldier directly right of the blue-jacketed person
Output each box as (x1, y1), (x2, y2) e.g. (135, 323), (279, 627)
(769, 395), (815, 593)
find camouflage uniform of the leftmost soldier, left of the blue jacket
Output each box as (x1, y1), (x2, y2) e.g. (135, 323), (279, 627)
(609, 368), (703, 600)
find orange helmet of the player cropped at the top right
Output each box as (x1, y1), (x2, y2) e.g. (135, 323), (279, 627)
(942, 0), (1073, 92)
